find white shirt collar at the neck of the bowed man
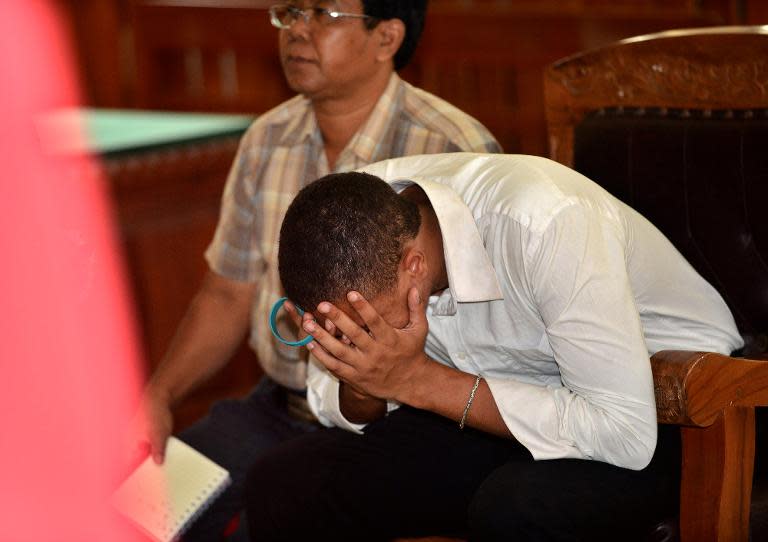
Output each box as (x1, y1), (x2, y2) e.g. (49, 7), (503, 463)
(388, 178), (504, 303)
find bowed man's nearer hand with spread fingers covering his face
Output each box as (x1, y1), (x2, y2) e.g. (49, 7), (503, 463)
(303, 288), (430, 403)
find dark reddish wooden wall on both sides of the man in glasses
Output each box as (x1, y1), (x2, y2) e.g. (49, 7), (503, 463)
(126, 0), (730, 154)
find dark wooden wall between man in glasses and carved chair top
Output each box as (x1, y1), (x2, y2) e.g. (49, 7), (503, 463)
(403, 4), (722, 155)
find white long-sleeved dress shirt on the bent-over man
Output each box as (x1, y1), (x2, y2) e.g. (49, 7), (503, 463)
(308, 153), (743, 469)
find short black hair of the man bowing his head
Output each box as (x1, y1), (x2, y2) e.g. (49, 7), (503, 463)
(278, 172), (421, 310)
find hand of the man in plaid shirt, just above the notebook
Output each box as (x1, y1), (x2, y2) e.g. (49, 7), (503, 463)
(128, 386), (173, 465)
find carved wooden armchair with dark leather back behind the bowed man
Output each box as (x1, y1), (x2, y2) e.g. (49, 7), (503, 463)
(545, 27), (768, 542)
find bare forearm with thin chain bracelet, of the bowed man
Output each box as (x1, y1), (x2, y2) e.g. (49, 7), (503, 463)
(397, 358), (513, 438)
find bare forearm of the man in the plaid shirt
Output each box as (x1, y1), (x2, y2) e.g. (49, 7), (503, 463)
(147, 273), (255, 405)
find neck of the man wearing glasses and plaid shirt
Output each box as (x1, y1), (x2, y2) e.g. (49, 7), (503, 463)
(312, 70), (392, 170)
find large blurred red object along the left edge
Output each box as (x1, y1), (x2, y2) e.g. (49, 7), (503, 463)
(0, 0), (145, 542)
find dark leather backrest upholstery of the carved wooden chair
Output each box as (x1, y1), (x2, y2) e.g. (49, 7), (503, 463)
(573, 108), (768, 354)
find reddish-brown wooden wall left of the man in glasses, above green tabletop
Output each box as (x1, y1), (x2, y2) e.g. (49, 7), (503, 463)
(133, 3), (292, 113)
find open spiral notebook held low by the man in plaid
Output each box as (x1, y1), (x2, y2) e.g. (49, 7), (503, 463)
(112, 437), (230, 542)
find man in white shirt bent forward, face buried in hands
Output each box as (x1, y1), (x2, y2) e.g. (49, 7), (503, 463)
(248, 153), (743, 542)
